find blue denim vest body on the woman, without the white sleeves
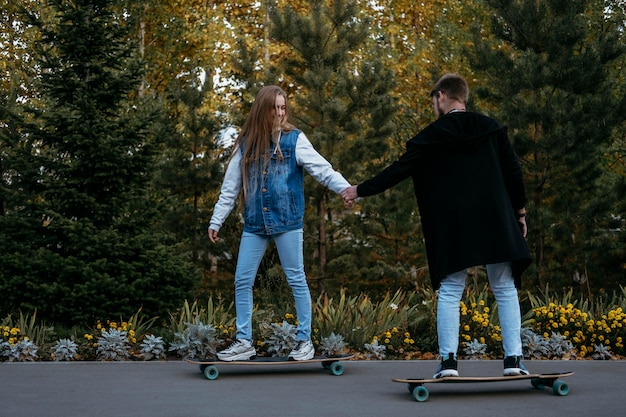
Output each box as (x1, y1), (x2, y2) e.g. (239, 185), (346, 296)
(242, 129), (304, 235)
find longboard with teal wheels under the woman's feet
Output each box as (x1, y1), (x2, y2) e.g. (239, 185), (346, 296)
(185, 355), (354, 380)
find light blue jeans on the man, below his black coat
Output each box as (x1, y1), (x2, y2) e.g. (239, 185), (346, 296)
(437, 262), (522, 357)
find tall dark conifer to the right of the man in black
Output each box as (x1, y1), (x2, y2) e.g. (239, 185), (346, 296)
(473, 0), (626, 287)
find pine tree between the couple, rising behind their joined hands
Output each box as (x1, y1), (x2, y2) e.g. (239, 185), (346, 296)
(270, 0), (395, 292)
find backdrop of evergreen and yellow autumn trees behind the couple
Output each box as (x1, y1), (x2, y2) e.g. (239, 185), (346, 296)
(0, 0), (626, 334)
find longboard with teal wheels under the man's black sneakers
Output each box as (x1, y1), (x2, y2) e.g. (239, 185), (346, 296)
(392, 372), (574, 402)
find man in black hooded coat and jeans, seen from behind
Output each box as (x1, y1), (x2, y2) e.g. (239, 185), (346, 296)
(341, 74), (531, 378)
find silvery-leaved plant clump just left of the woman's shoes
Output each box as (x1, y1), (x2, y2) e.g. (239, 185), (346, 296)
(169, 319), (222, 359)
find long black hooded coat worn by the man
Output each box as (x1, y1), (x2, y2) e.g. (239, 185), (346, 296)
(357, 112), (531, 289)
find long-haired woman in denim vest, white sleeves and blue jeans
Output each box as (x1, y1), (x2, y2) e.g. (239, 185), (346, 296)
(209, 85), (350, 361)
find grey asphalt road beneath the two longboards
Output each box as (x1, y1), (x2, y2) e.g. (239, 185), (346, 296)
(0, 361), (626, 417)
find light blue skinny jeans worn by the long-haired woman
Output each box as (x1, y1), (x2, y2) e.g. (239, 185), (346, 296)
(235, 229), (311, 340)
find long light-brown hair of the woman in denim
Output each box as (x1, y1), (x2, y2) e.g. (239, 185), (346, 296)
(235, 85), (294, 199)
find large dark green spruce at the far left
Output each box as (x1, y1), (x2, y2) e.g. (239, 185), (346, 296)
(0, 0), (196, 324)
